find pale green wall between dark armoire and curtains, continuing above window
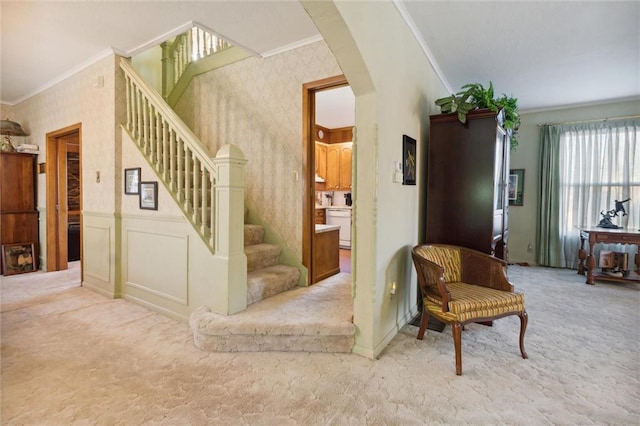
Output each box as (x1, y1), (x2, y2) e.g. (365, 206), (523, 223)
(509, 99), (640, 265)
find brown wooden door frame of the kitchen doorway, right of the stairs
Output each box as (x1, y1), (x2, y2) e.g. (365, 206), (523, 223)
(302, 75), (349, 285)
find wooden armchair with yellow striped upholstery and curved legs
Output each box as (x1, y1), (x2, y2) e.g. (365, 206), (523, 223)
(412, 244), (528, 376)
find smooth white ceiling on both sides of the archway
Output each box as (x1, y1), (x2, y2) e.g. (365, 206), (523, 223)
(0, 0), (640, 117)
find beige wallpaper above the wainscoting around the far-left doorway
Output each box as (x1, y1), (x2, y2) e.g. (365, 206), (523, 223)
(13, 55), (116, 212)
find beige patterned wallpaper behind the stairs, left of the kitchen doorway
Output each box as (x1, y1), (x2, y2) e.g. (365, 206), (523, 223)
(176, 41), (342, 259)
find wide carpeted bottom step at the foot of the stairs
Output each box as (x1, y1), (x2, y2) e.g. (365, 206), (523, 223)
(189, 273), (355, 352)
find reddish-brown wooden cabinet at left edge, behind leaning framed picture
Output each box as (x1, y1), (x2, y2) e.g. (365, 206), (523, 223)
(0, 152), (39, 269)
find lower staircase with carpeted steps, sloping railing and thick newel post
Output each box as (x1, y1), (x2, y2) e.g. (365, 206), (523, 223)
(121, 55), (355, 352)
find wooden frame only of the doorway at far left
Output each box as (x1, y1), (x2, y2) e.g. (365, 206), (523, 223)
(45, 123), (82, 272)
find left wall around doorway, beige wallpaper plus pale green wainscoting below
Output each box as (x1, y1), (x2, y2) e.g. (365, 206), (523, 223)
(13, 55), (117, 296)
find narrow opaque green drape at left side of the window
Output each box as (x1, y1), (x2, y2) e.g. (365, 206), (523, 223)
(536, 125), (561, 267)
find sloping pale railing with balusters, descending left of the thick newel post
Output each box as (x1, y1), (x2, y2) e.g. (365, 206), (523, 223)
(120, 59), (218, 252)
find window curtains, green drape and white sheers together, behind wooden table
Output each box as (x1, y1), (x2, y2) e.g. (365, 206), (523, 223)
(536, 119), (640, 268)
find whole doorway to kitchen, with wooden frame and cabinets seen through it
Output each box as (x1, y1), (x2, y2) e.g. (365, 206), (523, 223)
(303, 76), (355, 284)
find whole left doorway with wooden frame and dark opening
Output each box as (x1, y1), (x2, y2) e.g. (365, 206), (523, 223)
(45, 123), (82, 271)
